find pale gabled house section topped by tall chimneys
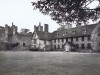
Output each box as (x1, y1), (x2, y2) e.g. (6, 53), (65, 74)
(31, 24), (51, 50)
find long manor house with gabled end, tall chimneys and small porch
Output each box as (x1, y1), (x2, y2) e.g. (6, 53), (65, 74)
(31, 23), (100, 52)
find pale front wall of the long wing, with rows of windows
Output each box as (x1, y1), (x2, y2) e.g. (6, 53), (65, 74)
(52, 36), (91, 50)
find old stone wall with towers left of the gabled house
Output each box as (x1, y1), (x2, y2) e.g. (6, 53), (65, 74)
(0, 23), (32, 49)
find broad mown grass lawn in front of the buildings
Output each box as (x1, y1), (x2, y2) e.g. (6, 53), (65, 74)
(0, 51), (100, 75)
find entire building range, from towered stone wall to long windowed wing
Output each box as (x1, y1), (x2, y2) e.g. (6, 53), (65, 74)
(0, 23), (100, 52)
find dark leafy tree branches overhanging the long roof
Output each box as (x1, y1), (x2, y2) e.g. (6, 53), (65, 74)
(32, 0), (100, 25)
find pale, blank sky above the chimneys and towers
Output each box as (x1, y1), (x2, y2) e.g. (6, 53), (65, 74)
(0, 0), (97, 32)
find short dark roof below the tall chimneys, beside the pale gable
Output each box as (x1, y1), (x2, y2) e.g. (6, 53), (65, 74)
(36, 31), (52, 40)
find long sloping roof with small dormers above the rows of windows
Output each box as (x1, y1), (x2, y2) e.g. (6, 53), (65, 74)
(52, 24), (98, 39)
